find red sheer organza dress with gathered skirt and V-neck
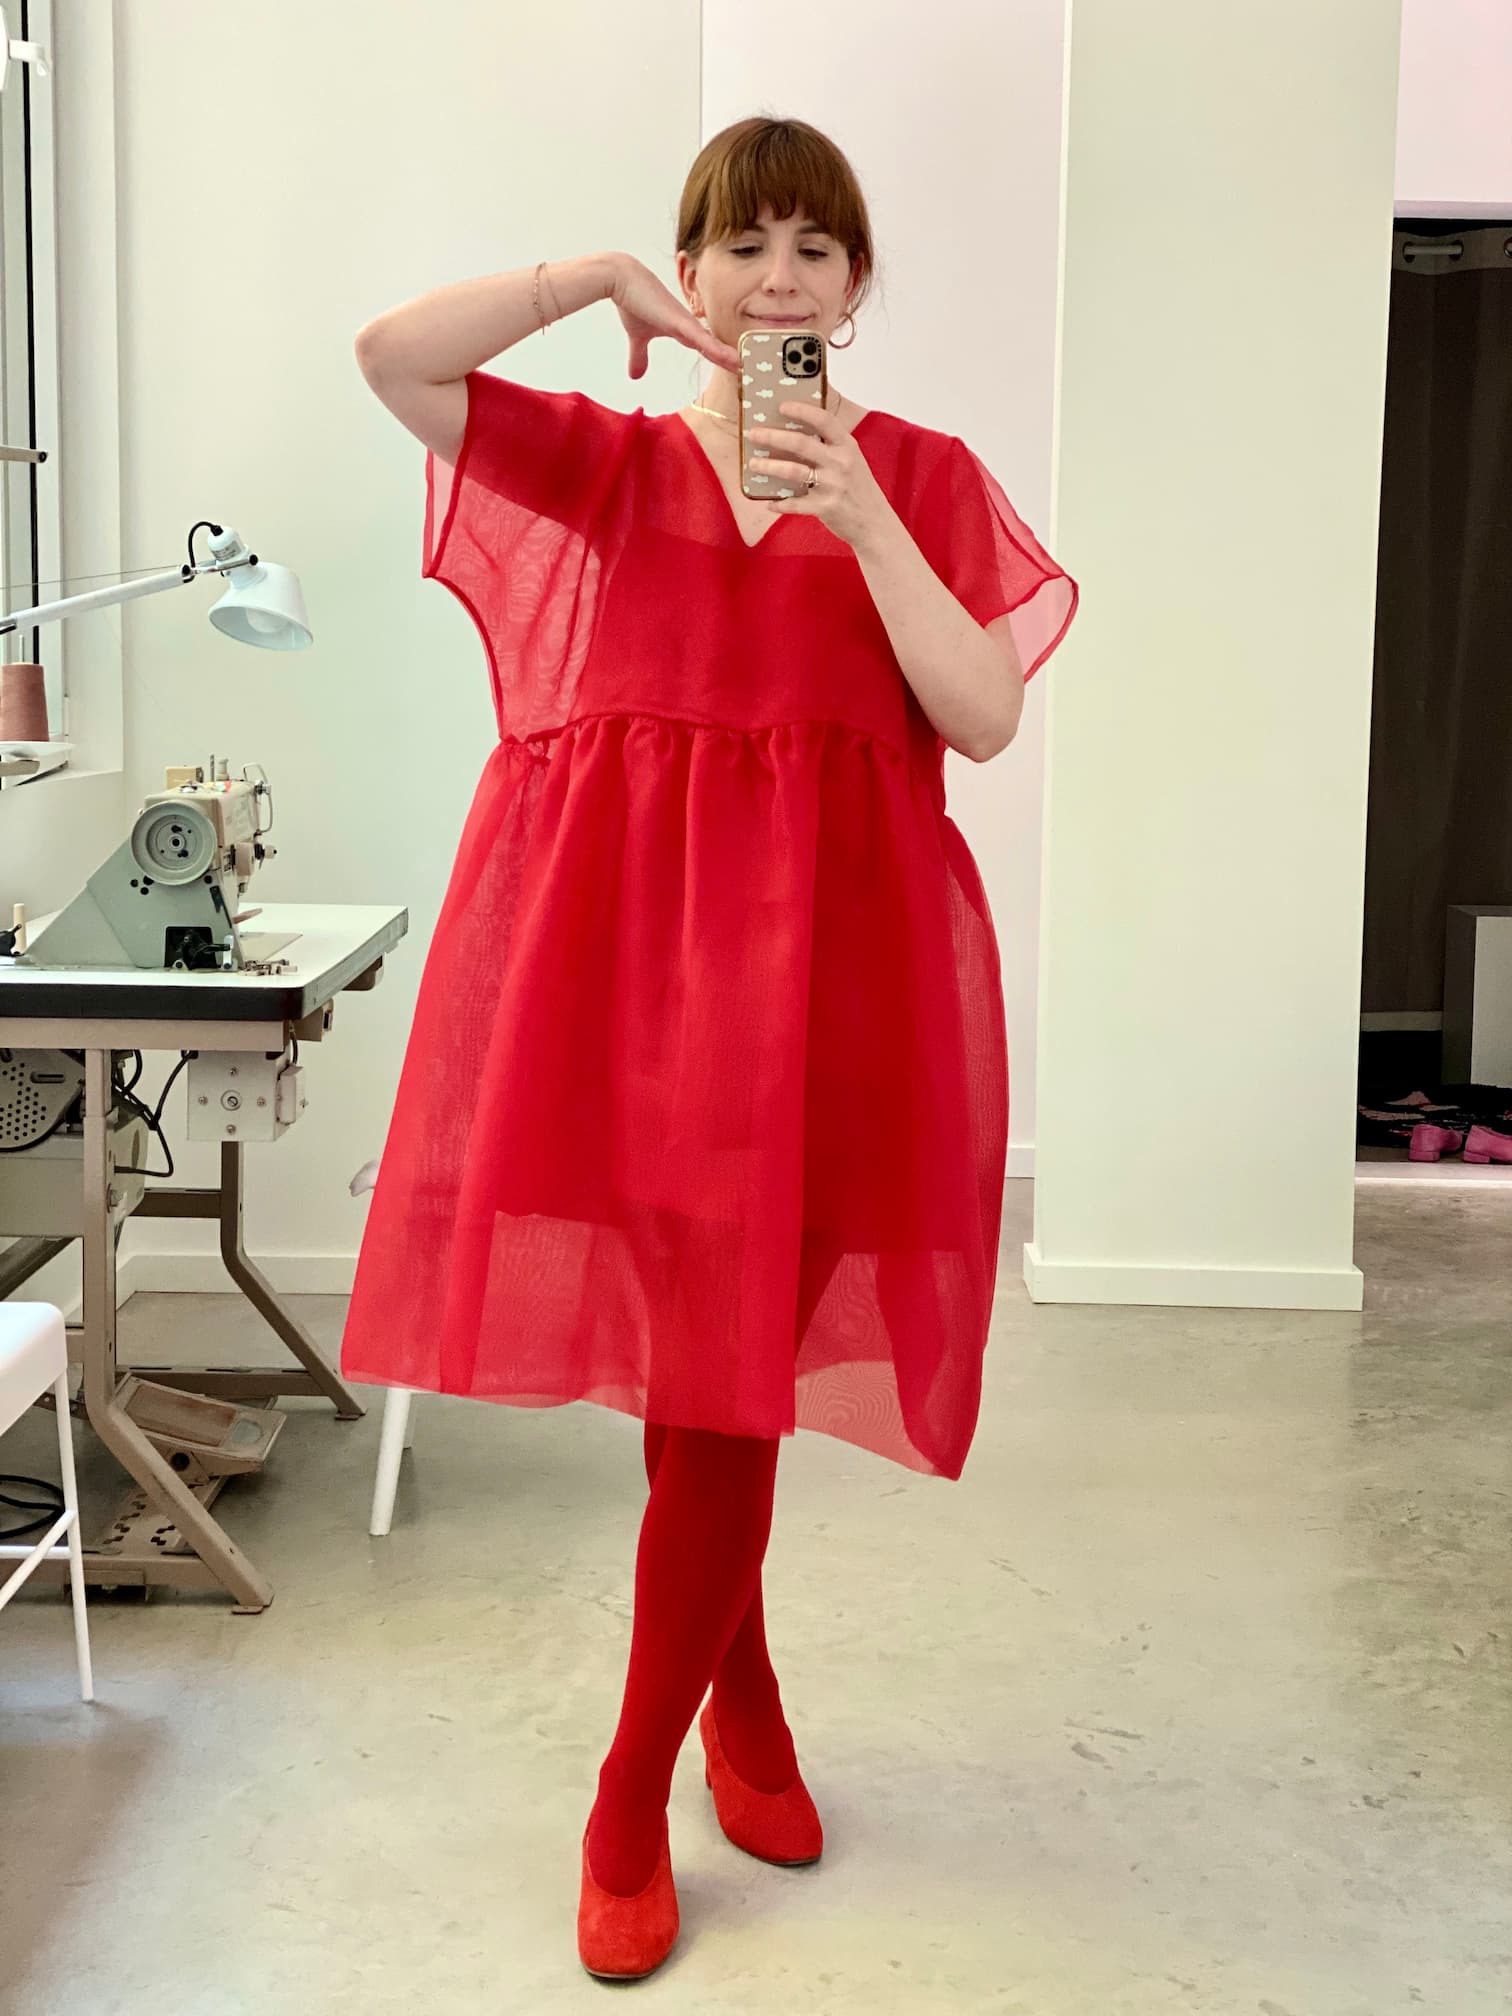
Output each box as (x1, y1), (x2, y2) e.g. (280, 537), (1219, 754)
(341, 371), (1077, 1478)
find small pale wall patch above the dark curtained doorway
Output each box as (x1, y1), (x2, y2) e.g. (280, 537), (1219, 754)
(1397, 0), (1512, 218)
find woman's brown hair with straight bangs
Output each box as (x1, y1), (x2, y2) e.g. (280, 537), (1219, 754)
(677, 119), (877, 312)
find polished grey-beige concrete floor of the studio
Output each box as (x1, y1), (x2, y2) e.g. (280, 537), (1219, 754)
(0, 1185), (1512, 2016)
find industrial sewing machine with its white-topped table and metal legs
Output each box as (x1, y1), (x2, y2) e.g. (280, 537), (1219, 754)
(0, 762), (407, 1611)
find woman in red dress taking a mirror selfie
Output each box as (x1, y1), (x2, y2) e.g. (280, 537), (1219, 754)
(343, 119), (1077, 1980)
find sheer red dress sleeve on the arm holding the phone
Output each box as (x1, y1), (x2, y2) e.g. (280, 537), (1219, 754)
(915, 437), (1079, 679)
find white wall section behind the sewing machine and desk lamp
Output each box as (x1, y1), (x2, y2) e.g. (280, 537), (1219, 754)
(109, 0), (698, 1290)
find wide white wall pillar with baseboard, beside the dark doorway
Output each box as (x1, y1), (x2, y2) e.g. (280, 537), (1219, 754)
(1026, 0), (1399, 1308)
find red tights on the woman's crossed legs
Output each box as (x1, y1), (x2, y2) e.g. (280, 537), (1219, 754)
(589, 1421), (798, 1897)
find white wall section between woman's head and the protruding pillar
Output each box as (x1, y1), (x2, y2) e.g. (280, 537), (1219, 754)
(704, 0), (1068, 1175)
